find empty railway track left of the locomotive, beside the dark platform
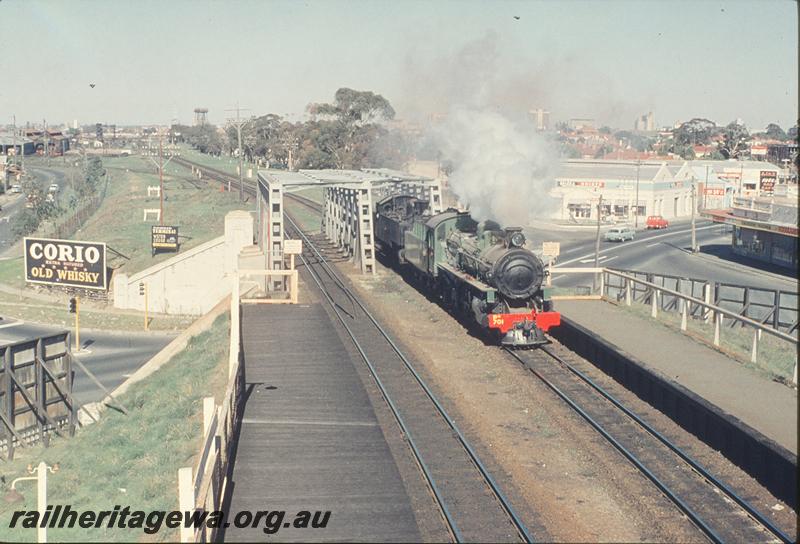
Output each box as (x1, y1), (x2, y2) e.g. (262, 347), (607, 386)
(287, 211), (534, 542)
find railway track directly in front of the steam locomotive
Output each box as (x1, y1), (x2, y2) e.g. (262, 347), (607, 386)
(506, 344), (794, 543)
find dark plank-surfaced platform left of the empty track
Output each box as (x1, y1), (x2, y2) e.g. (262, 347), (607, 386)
(224, 303), (421, 542)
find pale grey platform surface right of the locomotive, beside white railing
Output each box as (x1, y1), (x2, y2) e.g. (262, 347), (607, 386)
(557, 300), (798, 455)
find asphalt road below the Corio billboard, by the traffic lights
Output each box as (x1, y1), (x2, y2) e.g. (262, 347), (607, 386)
(0, 319), (175, 404)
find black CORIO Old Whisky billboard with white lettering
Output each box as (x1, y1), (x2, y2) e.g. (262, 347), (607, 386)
(24, 238), (108, 291)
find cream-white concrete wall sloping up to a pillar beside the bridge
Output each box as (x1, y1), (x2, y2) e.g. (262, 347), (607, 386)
(112, 211), (253, 315)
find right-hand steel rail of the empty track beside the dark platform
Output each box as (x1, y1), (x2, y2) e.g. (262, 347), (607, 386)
(286, 214), (534, 542)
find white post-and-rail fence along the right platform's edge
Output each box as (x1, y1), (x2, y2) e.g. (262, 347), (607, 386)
(553, 267), (798, 385)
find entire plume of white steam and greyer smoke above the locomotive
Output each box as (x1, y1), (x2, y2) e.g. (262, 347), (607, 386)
(400, 32), (559, 226)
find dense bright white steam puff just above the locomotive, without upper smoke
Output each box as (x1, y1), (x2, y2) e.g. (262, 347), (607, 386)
(435, 108), (558, 226)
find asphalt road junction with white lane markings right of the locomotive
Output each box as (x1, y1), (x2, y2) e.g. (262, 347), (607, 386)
(529, 221), (797, 290)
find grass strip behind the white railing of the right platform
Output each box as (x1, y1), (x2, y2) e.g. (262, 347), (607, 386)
(618, 302), (797, 383)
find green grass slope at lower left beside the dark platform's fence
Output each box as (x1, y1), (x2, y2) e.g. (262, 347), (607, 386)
(0, 314), (229, 542)
